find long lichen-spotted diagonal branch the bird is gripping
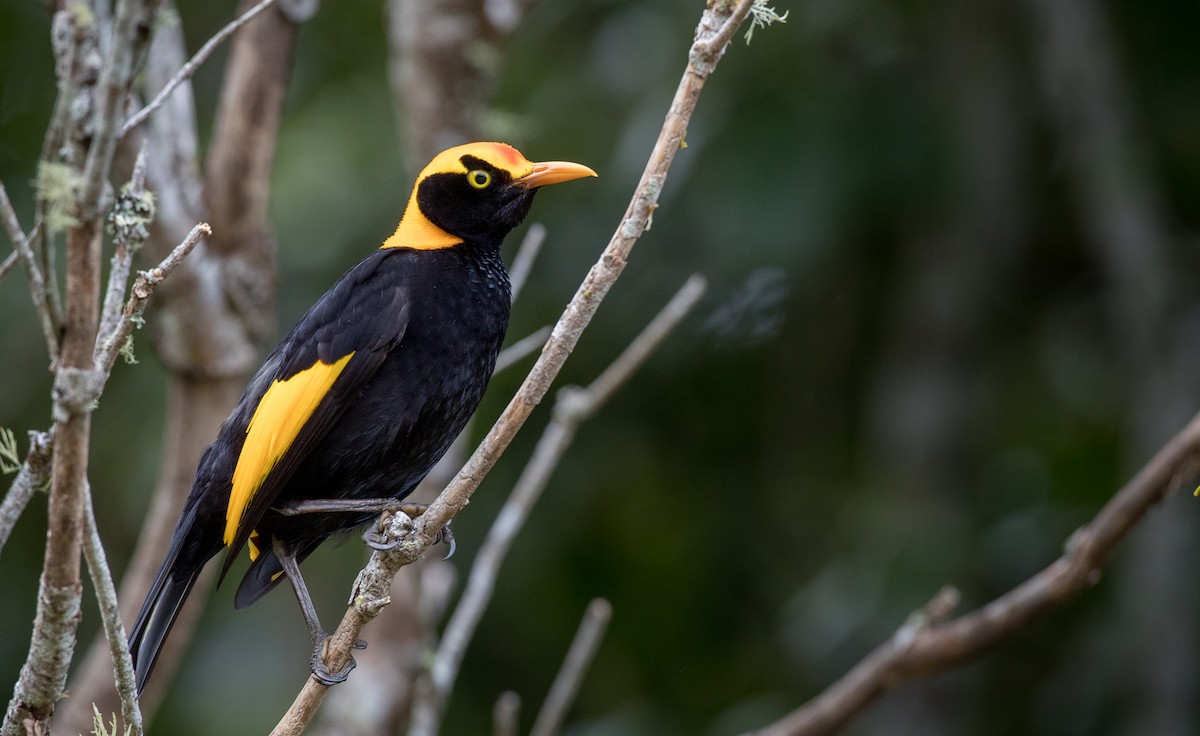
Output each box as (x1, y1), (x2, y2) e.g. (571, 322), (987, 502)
(274, 0), (755, 736)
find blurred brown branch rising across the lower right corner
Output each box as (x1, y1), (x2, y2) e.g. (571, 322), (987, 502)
(746, 414), (1200, 736)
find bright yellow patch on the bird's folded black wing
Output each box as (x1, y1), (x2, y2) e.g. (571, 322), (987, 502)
(224, 352), (354, 546)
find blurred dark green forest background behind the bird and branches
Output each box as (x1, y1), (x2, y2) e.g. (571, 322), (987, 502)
(0, 0), (1200, 736)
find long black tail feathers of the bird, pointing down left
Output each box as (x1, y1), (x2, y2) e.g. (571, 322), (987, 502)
(130, 509), (221, 695)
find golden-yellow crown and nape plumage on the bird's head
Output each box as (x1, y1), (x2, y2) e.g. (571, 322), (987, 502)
(380, 143), (533, 250)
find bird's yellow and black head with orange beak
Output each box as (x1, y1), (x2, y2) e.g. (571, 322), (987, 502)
(383, 143), (596, 250)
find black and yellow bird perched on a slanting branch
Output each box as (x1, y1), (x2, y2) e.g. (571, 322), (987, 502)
(128, 142), (596, 694)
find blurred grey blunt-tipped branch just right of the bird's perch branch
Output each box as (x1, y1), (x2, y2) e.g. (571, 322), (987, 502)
(409, 275), (704, 736)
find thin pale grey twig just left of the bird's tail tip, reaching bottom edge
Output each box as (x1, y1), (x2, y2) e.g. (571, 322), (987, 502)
(83, 484), (143, 736)
